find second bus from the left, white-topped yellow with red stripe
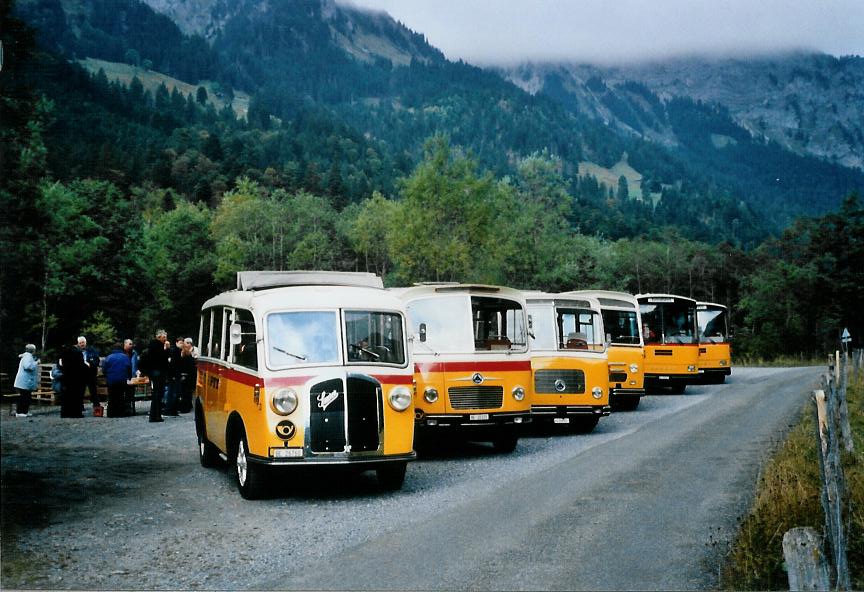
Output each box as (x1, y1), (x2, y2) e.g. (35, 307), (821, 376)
(393, 284), (531, 452)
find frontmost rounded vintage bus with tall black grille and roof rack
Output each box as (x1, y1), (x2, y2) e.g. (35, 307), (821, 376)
(194, 272), (415, 498)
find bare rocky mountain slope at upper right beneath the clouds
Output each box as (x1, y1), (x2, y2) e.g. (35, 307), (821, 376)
(503, 53), (864, 169)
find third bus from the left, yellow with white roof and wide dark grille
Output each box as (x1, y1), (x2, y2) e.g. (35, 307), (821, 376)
(524, 292), (611, 433)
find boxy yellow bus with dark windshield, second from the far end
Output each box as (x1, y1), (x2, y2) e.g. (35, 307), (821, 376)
(636, 294), (699, 394)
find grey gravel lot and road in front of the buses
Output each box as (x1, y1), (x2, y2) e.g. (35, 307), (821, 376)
(0, 368), (819, 590)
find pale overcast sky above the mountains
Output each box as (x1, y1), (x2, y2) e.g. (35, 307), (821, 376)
(343, 0), (864, 64)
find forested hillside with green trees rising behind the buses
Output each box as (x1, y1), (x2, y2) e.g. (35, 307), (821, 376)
(0, 0), (864, 371)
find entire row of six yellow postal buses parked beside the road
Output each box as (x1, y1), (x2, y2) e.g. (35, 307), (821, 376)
(194, 272), (731, 498)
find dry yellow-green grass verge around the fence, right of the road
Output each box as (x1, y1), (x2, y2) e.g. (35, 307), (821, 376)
(721, 370), (864, 590)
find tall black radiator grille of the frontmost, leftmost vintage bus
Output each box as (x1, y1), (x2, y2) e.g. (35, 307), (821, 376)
(309, 376), (383, 453)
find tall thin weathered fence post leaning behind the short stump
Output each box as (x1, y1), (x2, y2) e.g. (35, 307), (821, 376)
(813, 382), (851, 590)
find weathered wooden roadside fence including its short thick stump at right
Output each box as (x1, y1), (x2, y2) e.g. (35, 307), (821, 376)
(783, 349), (864, 590)
